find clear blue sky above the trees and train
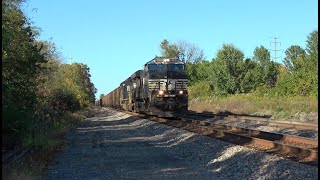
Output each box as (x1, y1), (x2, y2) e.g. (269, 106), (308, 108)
(24, 0), (318, 97)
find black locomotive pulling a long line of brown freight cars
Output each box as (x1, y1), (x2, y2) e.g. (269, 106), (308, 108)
(96, 57), (188, 117)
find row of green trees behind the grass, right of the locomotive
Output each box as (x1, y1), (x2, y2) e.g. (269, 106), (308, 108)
(160, 30), (318, 97)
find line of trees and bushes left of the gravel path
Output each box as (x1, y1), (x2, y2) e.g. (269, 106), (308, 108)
(2, 0), (96, 146)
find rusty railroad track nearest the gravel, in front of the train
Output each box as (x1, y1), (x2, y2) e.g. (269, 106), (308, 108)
(122, 112), (318, 166)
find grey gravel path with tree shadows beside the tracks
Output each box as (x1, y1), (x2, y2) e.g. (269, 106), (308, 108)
(44, 108), (318, 179)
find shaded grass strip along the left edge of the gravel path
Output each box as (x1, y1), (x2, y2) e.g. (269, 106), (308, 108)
(2, 108), (92, 180)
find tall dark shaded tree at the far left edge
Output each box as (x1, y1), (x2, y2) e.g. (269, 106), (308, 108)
(2, 0), (46, 139)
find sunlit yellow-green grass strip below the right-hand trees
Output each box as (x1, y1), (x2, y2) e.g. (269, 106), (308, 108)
(189, 94), (318, 122)
